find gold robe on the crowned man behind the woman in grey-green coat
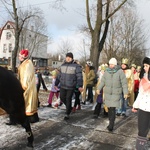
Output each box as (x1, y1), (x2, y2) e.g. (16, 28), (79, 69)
(124, 69), (134, 106)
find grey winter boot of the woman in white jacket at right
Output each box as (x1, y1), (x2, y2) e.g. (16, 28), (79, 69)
(136, 136), (148, 150)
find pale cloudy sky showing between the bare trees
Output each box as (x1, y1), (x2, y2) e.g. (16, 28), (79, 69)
(0, 0), (150, 56)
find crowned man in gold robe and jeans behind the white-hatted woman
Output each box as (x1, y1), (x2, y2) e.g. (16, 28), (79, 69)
(117, 58), (134, 116)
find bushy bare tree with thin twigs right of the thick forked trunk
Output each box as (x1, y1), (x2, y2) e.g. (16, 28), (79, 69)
(103, 7), (146, 64)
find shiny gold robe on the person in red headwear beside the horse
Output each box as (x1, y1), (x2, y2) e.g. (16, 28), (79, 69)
(18, 59), (38, 116)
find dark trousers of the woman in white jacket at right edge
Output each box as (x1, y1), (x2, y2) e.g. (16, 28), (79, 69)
(138, 109), (150, 137)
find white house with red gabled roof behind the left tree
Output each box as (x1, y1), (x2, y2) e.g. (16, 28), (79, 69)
(0, 21), (48, 67)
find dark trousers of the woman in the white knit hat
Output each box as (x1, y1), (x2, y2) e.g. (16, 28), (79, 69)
(108, 107), (116, 129)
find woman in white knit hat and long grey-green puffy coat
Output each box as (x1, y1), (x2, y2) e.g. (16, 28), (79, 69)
(97, 58), (128, 131)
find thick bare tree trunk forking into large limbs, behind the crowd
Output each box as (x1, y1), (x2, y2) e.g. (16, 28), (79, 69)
(86, 0), (127, 68)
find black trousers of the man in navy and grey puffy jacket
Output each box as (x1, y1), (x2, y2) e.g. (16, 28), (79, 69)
(60, 88), (74, 115)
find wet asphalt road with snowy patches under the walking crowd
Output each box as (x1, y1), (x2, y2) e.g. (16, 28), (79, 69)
(0, 92), (149, 150)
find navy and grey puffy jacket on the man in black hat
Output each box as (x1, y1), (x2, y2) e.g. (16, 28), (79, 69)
(55, 61), (83, 89)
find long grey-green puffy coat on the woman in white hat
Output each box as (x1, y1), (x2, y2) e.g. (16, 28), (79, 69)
(97, 66), (128, 107)
